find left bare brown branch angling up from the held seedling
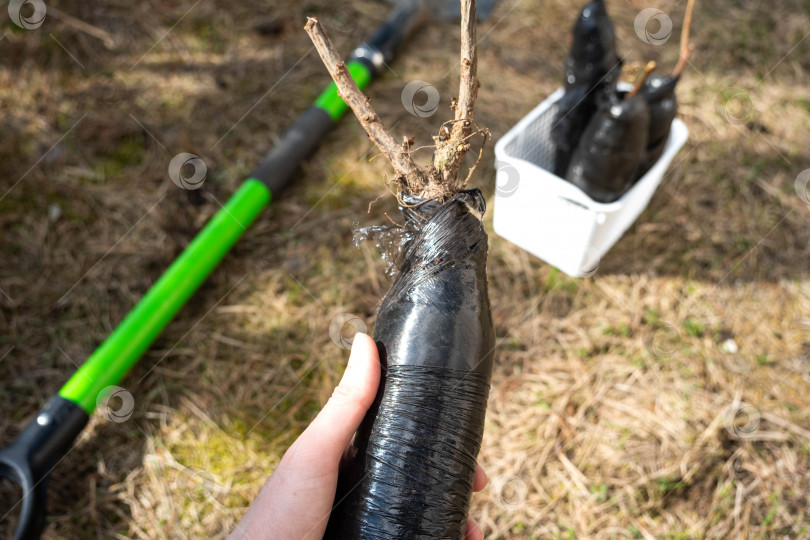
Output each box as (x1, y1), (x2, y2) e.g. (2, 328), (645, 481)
(304, 18), (427, 191)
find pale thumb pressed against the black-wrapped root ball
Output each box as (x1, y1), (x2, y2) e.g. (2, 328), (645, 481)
(288, 332), (380, 465)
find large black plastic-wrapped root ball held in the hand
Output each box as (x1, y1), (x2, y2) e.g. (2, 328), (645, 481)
(324, 190), (495, 540)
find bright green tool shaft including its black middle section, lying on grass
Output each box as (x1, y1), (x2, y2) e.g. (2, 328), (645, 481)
(59, 61), (371, 414)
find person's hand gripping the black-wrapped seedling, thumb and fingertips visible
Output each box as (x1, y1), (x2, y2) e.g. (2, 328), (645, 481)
(229, 333), (487, 540)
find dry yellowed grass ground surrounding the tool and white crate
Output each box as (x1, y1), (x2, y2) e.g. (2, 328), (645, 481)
(0, 0), (810, 539)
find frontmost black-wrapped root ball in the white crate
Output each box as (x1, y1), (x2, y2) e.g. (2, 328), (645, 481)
(566, 95), (650, 202)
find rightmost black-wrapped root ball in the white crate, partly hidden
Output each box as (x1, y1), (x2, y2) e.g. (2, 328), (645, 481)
(636, 75), (680, 179)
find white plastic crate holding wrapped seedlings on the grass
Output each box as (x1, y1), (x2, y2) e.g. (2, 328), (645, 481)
(493, 89), (689, 277)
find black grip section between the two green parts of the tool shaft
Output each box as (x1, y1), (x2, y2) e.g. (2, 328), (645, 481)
(250, 105), (335, 194)
